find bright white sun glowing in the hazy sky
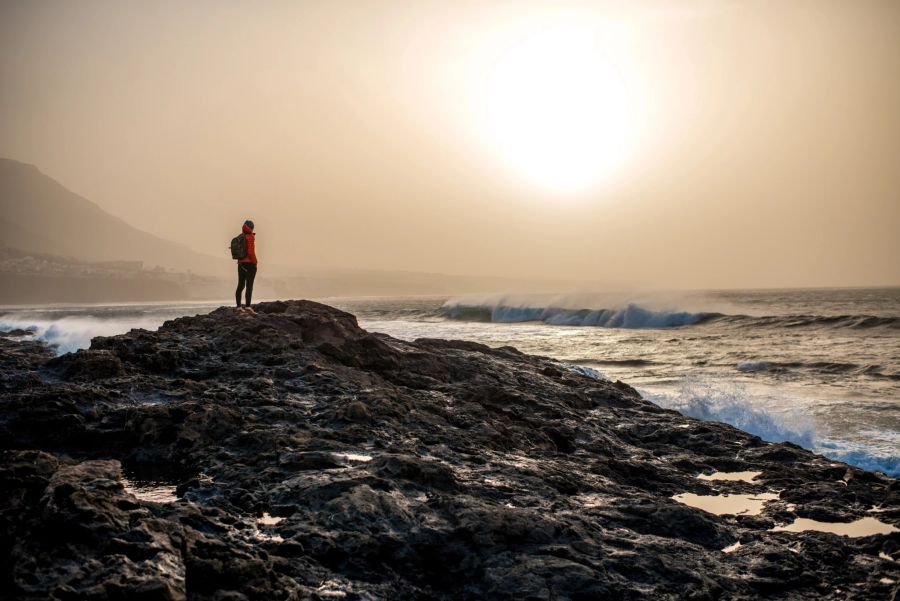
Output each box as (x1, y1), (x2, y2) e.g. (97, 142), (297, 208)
(485, 26), (633, 191)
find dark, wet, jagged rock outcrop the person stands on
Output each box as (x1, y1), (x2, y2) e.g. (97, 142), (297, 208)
(0, 301), (900, 600)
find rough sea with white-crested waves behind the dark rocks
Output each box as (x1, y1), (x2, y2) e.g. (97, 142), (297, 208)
(0, 288), (900, 477)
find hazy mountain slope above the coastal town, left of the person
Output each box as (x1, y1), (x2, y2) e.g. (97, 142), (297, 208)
(0, 159), (231, 275)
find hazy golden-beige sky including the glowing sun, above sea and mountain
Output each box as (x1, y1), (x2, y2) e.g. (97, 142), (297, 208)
(0, 0), (900, 287)
